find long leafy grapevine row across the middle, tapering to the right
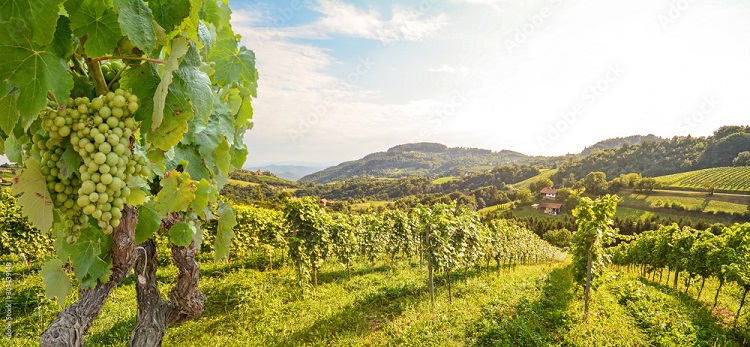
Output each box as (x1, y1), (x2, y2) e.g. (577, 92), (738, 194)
(198, 198), (565, 304)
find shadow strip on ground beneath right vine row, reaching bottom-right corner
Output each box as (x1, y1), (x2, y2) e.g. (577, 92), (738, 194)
(638, 277), (750, 346)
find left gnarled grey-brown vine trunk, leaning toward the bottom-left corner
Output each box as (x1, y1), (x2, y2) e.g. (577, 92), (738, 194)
(39, 206), (138, 347)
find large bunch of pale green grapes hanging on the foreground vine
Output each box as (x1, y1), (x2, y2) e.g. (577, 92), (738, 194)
(33, 89), (148, 239)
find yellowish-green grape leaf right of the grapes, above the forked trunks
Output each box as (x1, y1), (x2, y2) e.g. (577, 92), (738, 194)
(154, 170), (197, 216)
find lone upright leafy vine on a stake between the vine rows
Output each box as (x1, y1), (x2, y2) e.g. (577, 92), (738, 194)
(573, 195), (619, 316)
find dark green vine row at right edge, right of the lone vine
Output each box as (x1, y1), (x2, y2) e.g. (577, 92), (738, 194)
(612, 223), (750, 322)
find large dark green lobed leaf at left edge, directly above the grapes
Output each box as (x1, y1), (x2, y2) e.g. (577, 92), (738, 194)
(0, 18), (73, 130)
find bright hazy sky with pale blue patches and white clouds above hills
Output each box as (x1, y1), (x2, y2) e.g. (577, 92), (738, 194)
(0, 0), (750, 166)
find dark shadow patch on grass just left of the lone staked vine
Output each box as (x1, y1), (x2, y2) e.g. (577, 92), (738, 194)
(467, 266), (574, 346)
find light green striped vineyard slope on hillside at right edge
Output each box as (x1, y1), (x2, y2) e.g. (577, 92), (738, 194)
(656, 166), (750, 193)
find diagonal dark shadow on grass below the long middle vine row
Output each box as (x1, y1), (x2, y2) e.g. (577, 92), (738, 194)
(274, 284), (429, 346)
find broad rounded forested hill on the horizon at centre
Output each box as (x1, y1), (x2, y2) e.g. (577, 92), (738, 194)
(300, 142), (535, 183)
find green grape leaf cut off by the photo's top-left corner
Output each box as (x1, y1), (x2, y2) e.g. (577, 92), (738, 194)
(0, 0), (64, 45)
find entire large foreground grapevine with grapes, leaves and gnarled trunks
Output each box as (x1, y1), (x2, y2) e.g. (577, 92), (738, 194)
(0, 0), (258, 346)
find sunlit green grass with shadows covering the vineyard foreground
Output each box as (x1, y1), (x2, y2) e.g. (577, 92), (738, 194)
(11, 256), (748, 346)
